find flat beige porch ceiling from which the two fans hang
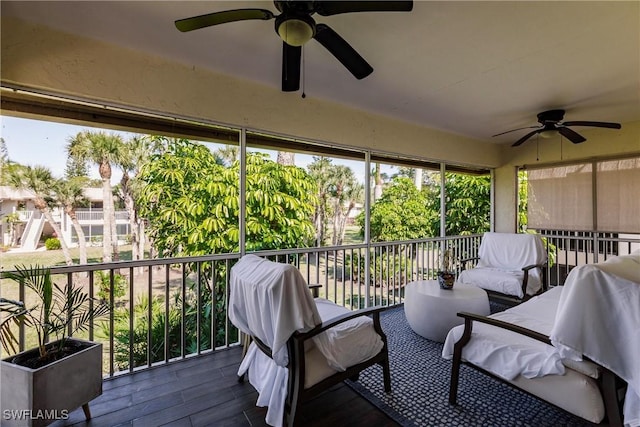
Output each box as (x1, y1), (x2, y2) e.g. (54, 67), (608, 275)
(1, 0), (640, 143)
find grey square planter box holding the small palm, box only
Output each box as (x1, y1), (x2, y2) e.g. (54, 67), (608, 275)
(0, 338), (102, 427)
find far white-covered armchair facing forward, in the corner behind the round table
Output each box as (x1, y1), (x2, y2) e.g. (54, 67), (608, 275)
(458, 232), (547, 302)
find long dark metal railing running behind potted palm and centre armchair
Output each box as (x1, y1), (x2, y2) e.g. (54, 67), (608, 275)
(2, 235), (480, 377)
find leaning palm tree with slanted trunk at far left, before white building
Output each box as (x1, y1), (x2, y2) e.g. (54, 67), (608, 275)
(9, 166), (73, 265)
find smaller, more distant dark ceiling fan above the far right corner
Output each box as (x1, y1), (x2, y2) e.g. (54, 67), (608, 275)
(493, 110), (622, 147)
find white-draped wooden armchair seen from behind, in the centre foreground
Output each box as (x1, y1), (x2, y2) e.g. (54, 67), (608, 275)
(229, 255), (391, 426)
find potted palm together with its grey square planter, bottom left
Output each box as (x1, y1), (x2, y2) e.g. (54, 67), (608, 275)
(0, 265), (110, 426)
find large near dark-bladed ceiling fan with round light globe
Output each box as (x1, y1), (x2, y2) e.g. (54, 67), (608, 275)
(175, 0), (413, 92)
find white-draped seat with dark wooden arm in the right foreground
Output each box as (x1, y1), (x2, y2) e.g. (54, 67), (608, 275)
(442, 254), (640, 426)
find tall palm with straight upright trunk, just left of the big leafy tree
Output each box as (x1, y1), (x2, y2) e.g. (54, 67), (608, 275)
(67, 131), (125, 262)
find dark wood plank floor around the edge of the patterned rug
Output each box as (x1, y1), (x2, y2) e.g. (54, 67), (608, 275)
(51, 347), (397, 427)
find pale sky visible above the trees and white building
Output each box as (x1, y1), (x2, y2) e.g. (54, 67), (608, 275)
(0, 116), (393, 184)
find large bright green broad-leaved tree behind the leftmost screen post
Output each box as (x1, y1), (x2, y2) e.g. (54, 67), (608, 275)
(138, 140), (316, 256)
